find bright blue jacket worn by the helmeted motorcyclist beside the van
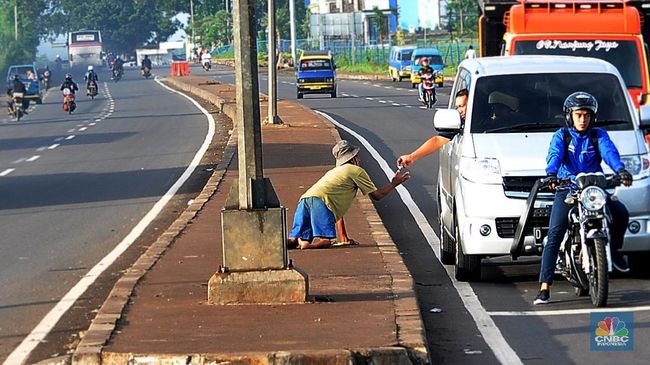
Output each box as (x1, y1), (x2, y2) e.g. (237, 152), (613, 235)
(546, 128), (625, 179)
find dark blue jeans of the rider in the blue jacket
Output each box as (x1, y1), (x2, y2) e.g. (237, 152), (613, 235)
(539, 190), (630, 285)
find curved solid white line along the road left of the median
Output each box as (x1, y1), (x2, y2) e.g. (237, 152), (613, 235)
(0, 75), (215, 365)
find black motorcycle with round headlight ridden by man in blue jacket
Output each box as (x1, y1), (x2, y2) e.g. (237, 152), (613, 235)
(513, 172), (621, 307)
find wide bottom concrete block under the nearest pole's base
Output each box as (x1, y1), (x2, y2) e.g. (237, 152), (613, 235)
(208, 267), (309, 305)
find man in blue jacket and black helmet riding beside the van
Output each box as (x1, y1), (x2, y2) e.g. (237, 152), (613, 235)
(533, 91), (632, 304)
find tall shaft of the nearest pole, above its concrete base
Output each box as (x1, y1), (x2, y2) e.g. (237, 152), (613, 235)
(233, 0), (265, 210)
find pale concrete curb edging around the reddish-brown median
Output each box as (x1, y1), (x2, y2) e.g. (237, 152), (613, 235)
(72, 77), (429, 365)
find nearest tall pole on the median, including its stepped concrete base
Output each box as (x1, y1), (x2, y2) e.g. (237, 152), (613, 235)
(208, 0), (308, 305)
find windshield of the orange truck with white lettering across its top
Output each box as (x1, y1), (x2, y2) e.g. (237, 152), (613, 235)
(514, 39), (643, 88)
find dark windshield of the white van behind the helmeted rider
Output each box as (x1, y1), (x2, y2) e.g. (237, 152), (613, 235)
(470, 73), (634, 133)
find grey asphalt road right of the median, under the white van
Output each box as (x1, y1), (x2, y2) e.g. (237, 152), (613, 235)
(205, 67), (650, 364)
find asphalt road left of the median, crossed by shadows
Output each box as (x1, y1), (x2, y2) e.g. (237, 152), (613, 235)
(0, 66), (215, 362)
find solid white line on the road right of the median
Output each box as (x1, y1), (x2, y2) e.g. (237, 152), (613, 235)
(316, 111), (523, 364)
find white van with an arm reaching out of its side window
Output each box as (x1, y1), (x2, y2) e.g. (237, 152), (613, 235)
(434, 56), (650, 280)
